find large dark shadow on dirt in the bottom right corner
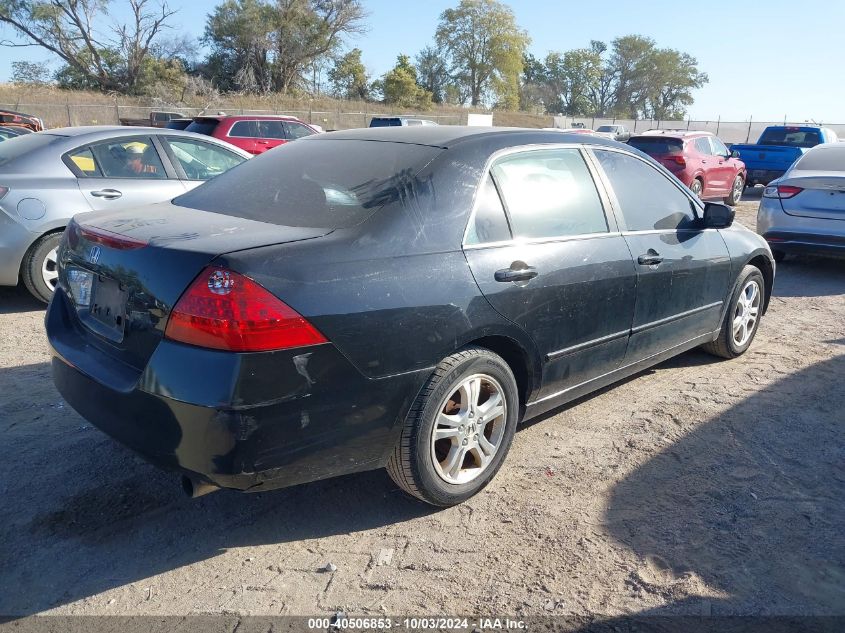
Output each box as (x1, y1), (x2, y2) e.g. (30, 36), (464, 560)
(585, 350), (845, 630)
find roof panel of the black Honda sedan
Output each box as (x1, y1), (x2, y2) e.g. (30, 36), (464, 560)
(310, 125), (620, 149)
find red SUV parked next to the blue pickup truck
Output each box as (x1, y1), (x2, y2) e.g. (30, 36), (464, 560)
(628, 130), (746, 206)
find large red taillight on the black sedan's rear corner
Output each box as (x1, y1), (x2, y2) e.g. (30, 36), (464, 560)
(164, 266), (326, 352)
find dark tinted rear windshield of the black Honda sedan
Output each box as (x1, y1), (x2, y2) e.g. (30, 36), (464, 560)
(173, 139), (442, 229)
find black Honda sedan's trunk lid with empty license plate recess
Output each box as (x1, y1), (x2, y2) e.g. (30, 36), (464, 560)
(59, 202), (331, 370)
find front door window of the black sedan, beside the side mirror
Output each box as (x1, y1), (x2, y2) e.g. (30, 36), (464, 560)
(596, 150), (695, 231)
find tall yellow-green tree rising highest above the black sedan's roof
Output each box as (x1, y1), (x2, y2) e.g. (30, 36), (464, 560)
(435, 0), (530, 109)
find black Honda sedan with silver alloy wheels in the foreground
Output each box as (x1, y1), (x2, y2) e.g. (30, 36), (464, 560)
(46, 126), (774, 506)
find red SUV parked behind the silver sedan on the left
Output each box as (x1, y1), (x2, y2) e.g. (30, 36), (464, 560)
(185, 114), (318, 154)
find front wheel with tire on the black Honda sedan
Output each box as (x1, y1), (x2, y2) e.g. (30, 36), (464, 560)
(701, 266), (766, 358)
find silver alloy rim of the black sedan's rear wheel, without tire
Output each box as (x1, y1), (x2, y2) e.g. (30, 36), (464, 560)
(431, 374), (507, 484)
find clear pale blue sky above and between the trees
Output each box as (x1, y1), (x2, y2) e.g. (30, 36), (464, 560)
(0, 0), (845, 123)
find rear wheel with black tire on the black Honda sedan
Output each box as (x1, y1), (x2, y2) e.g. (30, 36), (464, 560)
(387, 347), (519, 506)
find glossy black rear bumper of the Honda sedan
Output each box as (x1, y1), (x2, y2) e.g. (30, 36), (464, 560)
(46, 289), (427, 491)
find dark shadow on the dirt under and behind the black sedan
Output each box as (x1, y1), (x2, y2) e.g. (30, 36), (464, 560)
(0, 363), (438, 616)
